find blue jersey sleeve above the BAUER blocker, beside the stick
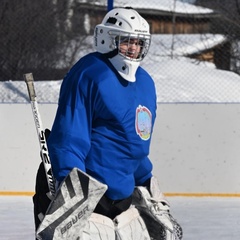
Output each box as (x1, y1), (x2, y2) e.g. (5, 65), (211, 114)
(48, 66), (94, 182)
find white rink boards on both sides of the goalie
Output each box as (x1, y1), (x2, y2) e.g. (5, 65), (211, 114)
(0, 104), (240, 194)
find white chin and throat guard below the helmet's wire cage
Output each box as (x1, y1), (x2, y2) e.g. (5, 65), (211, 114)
(104, 49), (140, 82)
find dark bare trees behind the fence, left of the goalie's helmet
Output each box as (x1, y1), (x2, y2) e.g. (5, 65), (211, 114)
(0, 0), (90, 80)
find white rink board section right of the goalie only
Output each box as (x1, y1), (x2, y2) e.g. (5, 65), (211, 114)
(151, 104), (240, 194)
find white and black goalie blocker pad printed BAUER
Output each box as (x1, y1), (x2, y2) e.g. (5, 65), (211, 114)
(36, 168), (107, 240)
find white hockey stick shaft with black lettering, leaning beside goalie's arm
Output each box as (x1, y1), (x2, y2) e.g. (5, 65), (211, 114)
(23, 73), (55, 200)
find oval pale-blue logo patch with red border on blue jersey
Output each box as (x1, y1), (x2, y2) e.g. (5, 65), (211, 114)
(135, 105), (152, 141)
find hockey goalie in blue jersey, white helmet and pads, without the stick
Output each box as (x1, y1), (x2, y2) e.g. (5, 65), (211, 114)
(34, 8), (182, 240)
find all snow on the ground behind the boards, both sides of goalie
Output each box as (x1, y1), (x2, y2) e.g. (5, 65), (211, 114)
(0, 57), (240, 103)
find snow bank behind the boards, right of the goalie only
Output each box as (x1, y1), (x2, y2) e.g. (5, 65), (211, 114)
(142, 60), (240, 103)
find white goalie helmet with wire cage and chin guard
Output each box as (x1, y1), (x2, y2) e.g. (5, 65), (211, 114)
(94, 8), (151, 82)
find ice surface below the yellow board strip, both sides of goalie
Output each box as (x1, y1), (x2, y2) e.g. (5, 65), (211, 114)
(0, 196), (240, 240)
